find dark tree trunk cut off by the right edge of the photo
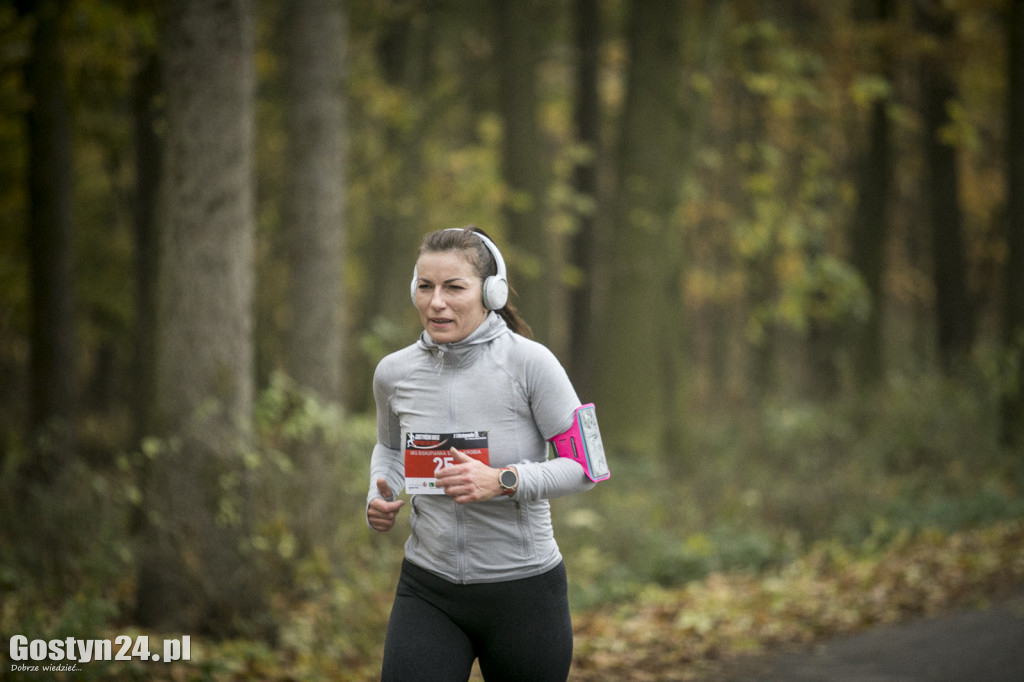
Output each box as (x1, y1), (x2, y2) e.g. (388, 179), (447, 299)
(1001, 0), (1024, 447)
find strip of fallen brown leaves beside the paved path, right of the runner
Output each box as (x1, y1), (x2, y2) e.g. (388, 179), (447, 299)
(572, 521), (1024, 682)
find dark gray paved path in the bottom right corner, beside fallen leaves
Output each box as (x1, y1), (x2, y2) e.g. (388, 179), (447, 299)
(715, 592), (1024, 682)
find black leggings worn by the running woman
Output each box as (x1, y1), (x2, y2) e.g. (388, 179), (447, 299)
(381, 561), (572, 682)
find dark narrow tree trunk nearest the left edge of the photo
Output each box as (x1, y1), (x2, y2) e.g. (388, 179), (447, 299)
(19, 0), (78, 473)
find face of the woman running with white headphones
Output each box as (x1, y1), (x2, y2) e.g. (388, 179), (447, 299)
(416, 251), (487, 343)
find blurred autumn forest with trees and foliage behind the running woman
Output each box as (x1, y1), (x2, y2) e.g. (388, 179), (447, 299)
(0, 0), (1024, 679)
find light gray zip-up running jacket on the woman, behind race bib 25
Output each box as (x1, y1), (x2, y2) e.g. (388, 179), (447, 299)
(367, 312), (594, 584)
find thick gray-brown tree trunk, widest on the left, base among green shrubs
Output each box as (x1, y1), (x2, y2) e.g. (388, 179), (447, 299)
(137, 0), (263, 636)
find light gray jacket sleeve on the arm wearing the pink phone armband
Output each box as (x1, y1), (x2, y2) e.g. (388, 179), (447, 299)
(514, 343), (595, 502)
